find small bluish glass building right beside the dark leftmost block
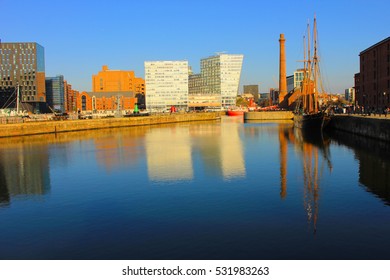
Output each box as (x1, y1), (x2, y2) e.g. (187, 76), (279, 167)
(46, 75), (66, 112)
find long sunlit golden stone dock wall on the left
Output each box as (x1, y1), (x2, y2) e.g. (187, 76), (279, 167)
(0, 112), (221, 137)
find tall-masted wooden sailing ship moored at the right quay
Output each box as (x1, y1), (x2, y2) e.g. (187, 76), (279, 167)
(294, 17), (328, 130)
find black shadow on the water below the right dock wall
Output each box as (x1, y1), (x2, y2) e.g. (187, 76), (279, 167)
(329, 130), (390, 205)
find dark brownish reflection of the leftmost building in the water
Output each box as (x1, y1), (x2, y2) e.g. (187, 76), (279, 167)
(0, 141), (50, 206)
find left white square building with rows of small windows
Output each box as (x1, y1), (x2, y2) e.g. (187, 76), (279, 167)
(145, 60), (189, 110)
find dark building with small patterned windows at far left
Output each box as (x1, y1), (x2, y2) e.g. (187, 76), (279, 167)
(0, 42), (46, 112)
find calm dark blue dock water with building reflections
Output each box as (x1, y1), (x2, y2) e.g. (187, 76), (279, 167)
(0, 118), (390, 259)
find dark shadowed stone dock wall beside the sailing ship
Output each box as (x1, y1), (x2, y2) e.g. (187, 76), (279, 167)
(329, 115), (390, 141)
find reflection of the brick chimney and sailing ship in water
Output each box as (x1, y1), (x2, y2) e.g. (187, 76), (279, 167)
(279, 125), (332, 234)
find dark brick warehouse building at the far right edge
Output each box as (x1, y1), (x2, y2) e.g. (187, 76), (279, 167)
(355, 37), (390, 110)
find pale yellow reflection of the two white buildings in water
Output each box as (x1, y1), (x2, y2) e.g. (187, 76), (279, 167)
(145, 118), (246, 181)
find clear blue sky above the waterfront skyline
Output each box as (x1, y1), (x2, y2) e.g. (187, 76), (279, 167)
(0, 0), (390, 93)
